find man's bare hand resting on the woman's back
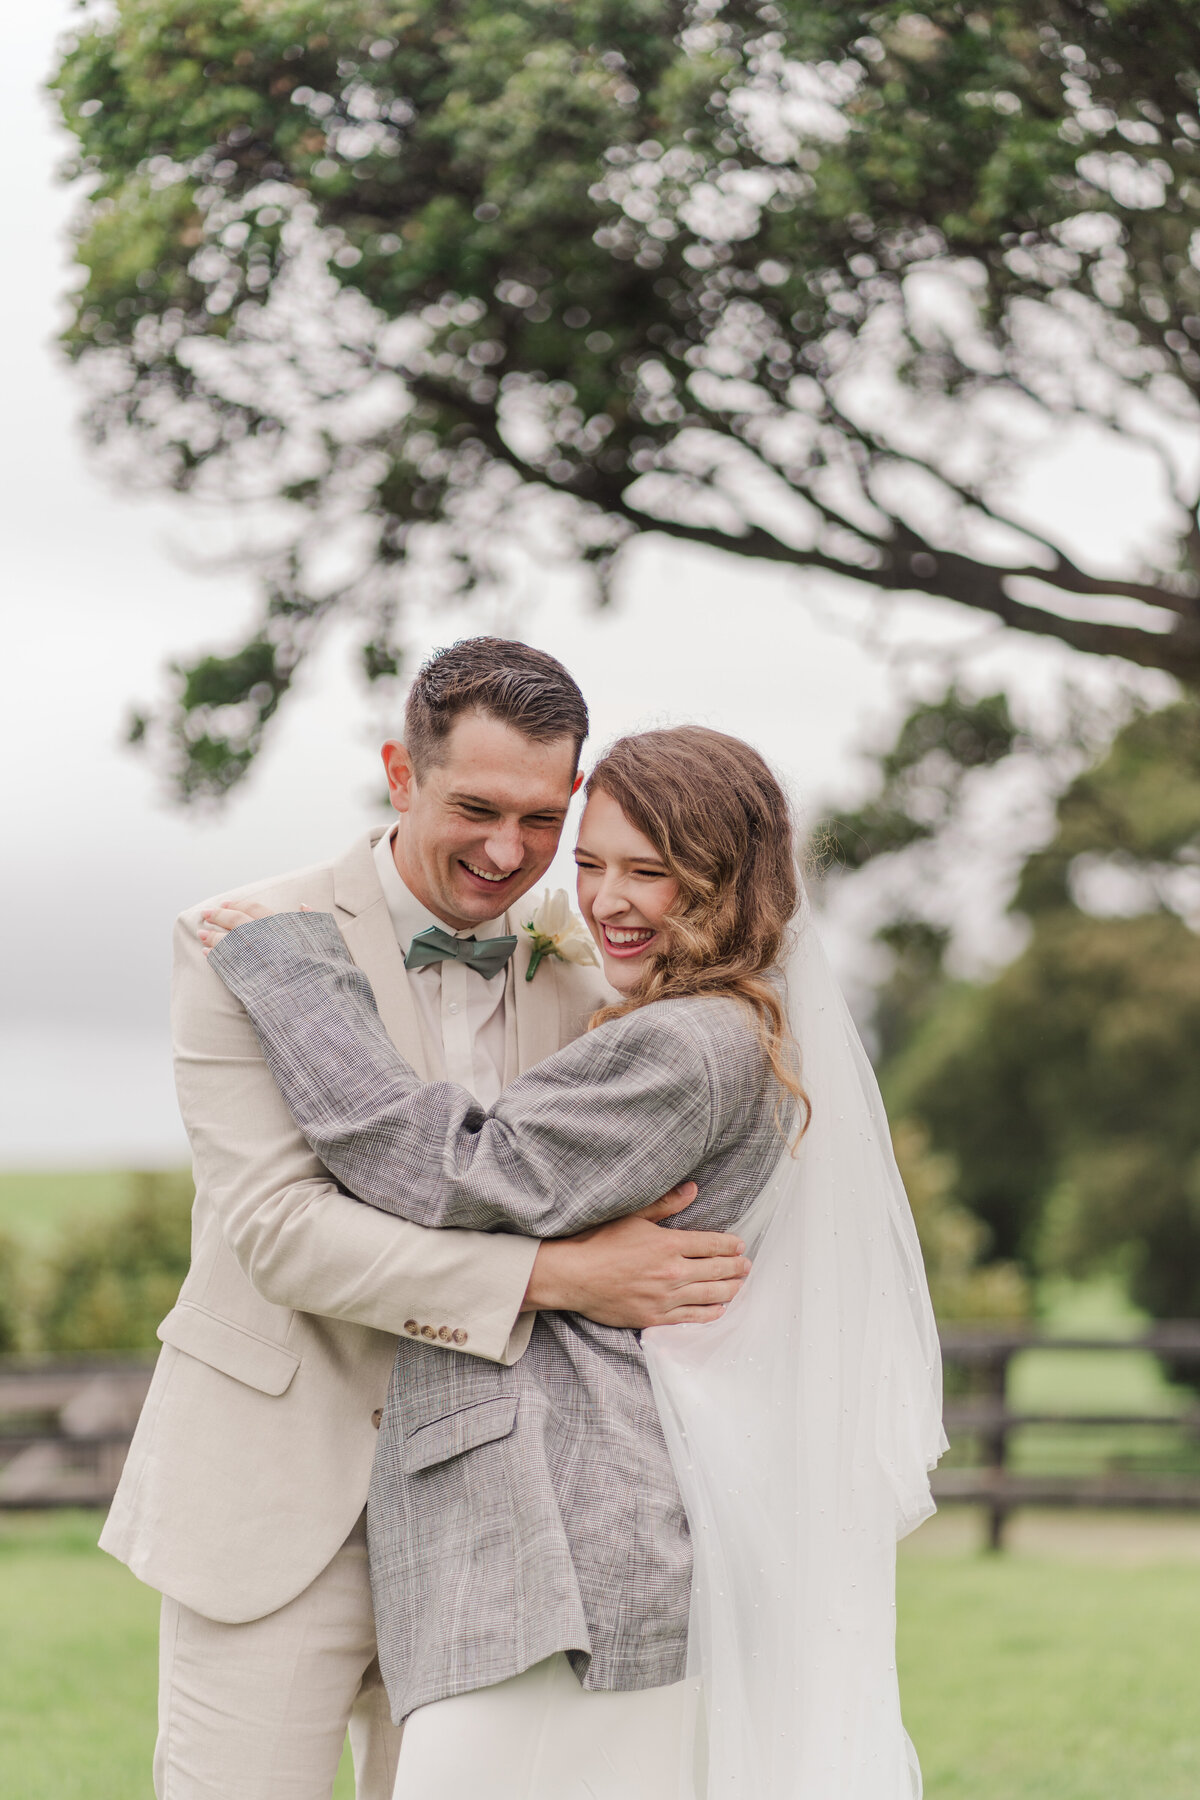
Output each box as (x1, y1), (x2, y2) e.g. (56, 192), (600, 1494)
(522, 1181), (750, 1330)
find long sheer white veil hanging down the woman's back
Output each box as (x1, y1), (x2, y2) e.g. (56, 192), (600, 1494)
(642, 902), (946, 1800)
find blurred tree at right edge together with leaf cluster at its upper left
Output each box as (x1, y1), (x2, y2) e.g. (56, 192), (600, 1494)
(828, 693), (1200, 1339)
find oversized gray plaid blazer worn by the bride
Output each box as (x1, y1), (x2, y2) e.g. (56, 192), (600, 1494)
(210, 913), (783, 1721)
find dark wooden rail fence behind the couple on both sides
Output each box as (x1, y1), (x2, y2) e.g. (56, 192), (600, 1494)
(0, 1319), (1200, 1550)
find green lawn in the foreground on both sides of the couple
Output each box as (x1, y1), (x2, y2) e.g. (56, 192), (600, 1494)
(0, 1514), (1200, 1800)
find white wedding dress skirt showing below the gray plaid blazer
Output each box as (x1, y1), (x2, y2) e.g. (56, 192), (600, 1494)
(394, 1652), (705, 1800)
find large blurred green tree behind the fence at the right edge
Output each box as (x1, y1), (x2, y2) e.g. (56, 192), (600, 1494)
(863, 700), (1200, 1318)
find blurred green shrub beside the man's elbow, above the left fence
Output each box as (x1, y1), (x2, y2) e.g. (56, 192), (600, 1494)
(38, 1172), (193, 1352)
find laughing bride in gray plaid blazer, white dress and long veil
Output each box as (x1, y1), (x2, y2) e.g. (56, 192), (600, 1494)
(201, 727), (945, 1800)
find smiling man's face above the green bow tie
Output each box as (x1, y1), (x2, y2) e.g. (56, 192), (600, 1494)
(383, 713), (576, 931)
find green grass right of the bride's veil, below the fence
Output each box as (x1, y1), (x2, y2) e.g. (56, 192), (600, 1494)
(900, 1555), (1200, 1800)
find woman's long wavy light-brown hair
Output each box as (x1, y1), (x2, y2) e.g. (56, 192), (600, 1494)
(587, 725), (811, 1132)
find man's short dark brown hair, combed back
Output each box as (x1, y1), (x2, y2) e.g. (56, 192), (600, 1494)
(405, 637), (588, 776)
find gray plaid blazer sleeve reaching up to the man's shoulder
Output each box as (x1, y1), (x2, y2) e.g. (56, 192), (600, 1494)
(210, 913), (763, 1237)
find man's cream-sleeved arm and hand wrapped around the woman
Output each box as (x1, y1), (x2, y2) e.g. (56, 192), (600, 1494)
(171, 913), (748, 1363)
